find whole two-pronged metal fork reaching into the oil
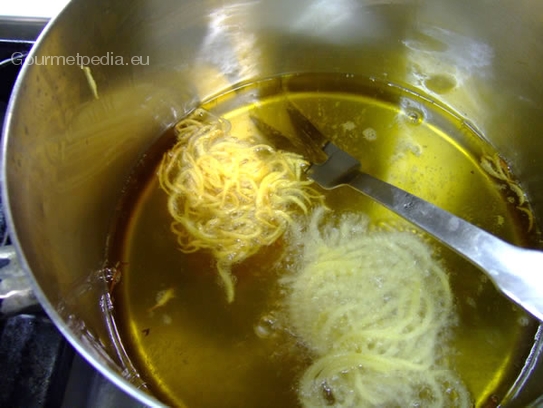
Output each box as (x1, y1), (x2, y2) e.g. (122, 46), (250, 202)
(252, 103), (543, 321)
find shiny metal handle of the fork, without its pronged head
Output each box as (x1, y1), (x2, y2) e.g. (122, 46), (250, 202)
(345, 171), (543, 321)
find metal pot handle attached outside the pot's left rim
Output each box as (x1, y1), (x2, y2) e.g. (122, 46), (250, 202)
(0, 245), (40, 319)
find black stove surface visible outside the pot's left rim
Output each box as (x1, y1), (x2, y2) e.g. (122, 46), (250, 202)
(0, 24), (147, 408)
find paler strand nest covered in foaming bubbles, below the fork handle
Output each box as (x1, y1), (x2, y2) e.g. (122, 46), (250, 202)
(282, 210), (471, 408)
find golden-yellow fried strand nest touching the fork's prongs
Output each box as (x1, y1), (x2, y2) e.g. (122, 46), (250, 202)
(158, 109), (323, 302)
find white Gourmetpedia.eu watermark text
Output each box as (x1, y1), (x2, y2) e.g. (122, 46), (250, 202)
(11, 52), (149, 66)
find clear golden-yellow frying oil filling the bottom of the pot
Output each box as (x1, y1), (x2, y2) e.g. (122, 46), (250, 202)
(111, 75), (536, 408)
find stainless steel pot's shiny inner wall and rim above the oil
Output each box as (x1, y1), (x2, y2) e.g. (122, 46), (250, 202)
(3, 0), (543, 407)
